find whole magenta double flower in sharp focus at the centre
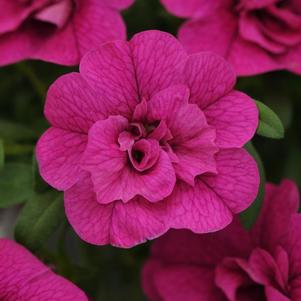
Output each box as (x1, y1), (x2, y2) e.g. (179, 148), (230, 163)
(37, 31), (259, 247)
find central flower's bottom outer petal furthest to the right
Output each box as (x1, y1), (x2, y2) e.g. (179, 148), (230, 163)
(166, 180), (233, 233)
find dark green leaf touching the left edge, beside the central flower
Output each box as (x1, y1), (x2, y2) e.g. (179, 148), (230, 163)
(0, 163), (33, 208)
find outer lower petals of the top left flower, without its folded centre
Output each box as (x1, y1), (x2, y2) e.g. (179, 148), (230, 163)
(0, 0), (126, 65)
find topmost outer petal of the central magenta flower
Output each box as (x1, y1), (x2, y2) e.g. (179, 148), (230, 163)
(129, 30), (187, 100)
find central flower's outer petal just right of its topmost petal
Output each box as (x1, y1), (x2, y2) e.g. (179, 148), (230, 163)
(184, 52), (236, 109)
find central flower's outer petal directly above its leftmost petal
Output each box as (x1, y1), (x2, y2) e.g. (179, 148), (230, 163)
(44, 73), (106, 133)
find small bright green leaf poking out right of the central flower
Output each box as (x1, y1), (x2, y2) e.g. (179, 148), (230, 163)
(256, 101), (284, 139)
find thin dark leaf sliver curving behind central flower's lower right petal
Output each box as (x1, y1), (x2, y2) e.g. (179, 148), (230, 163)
(240, 142), (266, 229)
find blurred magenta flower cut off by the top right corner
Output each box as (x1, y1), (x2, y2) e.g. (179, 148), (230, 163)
(161, 0), (301, 75)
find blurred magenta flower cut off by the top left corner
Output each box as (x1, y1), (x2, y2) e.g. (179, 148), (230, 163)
(0, 0), (134, 66)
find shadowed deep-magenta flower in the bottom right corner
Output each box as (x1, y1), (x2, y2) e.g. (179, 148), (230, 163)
(142, 180), (301, 301)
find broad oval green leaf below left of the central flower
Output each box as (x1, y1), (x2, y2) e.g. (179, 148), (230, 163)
(15, 191), (65, 250)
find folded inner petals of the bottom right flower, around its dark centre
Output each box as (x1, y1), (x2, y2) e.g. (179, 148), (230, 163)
(216, 246), (290, 300)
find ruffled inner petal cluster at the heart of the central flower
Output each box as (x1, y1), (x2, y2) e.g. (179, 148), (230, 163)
(82, 86), (218, 203)
